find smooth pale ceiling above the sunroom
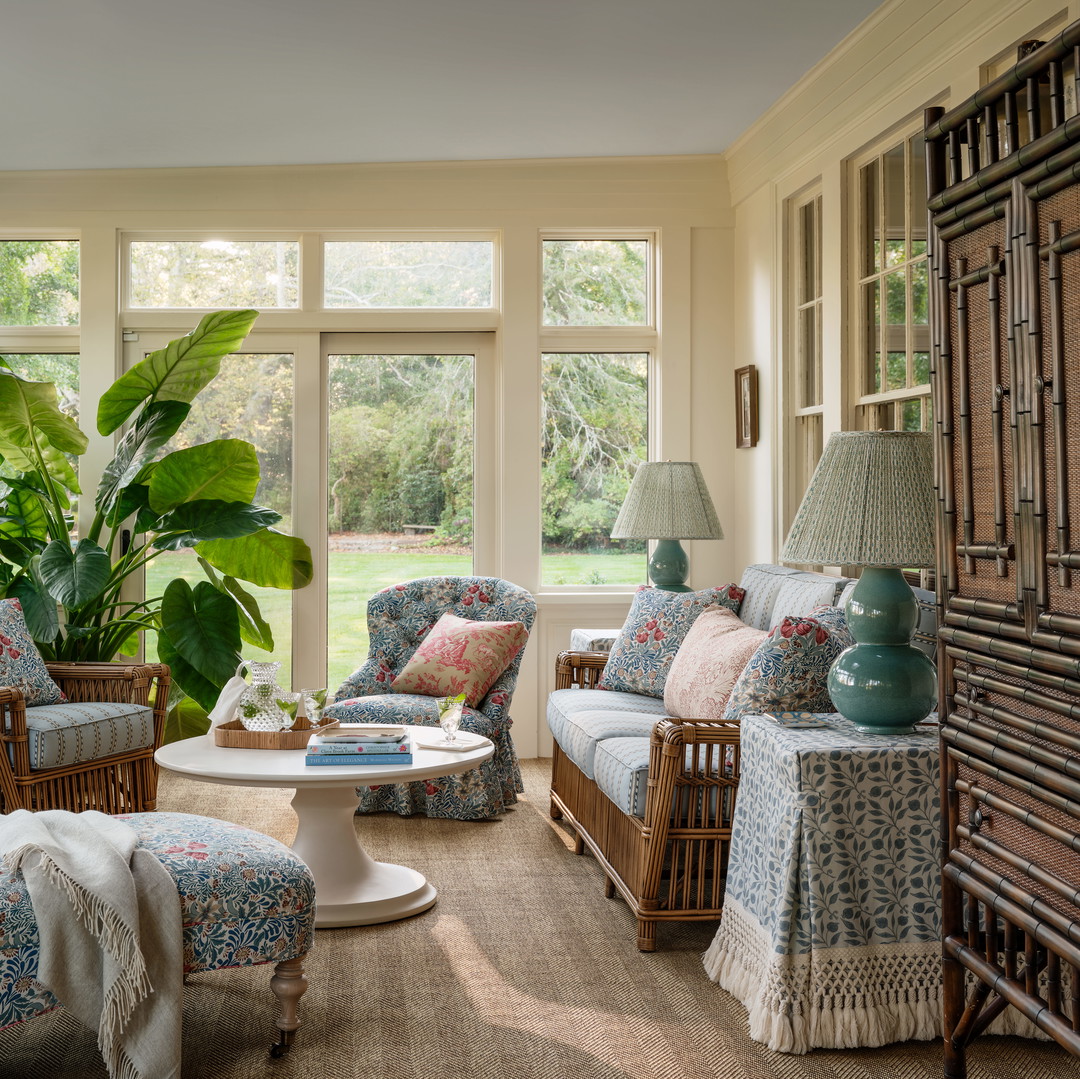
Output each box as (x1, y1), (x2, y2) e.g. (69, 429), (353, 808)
(0, 0), (880, 170)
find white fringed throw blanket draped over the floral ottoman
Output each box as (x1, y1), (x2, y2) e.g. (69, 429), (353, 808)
(0, 809), (184, 1079)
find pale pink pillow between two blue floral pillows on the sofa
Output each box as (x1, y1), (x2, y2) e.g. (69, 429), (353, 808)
(664, 607), (769, 719)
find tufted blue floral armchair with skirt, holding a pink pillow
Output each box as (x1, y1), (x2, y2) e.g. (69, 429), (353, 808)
(326, 577), (536, 820)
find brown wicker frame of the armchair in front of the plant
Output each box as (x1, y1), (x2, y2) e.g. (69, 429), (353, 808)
(0, 663), (170, 813)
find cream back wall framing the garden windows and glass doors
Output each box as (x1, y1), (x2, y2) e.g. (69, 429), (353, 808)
(0, 152), (734, 757)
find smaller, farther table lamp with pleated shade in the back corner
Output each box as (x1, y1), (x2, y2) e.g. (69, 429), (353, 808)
(611, 461), (724, 592)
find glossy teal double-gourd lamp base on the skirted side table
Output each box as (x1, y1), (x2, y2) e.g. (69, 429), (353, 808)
(828, 567), (937, 734)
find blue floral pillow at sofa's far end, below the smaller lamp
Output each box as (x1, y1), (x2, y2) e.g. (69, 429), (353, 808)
(597, 584), (746, 697)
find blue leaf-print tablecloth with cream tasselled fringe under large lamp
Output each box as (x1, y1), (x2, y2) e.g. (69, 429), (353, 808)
(704, 714), (942, 1053)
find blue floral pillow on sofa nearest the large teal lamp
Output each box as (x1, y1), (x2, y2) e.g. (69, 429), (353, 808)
(724, 607), (854, 719)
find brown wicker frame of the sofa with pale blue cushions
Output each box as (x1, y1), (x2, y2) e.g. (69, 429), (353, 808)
(551, 651), (741, 952)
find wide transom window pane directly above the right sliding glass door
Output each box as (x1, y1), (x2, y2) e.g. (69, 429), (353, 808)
(323, 240), (495, 308)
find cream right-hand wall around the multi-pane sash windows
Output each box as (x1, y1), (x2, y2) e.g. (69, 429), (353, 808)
(725, 0), (1080, 563)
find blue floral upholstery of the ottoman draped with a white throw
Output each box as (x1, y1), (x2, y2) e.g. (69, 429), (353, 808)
(0, 813), (315, 1028)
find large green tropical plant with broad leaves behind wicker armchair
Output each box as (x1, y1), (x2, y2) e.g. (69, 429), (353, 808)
(0, 311), (311, 723)
